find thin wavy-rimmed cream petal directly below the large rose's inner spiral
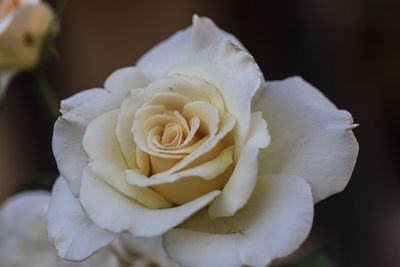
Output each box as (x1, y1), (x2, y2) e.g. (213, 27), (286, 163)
(126, 146), (233, 187)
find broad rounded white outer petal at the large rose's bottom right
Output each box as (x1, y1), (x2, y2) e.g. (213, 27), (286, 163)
(164, 175), (313, 267)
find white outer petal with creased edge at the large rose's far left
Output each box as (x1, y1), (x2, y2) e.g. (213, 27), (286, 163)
(52, 89), (120, 196)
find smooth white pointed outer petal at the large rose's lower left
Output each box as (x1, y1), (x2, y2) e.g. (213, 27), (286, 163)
(48, 177), (114, 261)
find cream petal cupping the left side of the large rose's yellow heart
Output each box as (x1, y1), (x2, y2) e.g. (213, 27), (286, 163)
(82, 110), (171, 208)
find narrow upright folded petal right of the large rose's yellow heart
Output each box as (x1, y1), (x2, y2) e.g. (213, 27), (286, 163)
(209, 112), (270, 218)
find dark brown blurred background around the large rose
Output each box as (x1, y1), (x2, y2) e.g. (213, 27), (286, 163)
(0, 0), (400, 267)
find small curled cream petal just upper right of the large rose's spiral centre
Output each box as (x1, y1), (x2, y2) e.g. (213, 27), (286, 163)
(182, 101), (220, 137)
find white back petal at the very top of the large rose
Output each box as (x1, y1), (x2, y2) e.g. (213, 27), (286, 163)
(137, 15), (243, 81)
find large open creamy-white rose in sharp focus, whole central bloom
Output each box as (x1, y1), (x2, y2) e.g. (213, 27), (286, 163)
(48, 16), (358, 266)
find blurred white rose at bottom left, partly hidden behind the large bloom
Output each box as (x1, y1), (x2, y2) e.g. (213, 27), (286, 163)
(0, 191), (178, 267)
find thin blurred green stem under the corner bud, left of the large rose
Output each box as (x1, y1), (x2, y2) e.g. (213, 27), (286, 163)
(35, 74), (60, 120)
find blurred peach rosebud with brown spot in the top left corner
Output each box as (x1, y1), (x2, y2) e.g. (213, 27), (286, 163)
(0, 0), (54, 71)
